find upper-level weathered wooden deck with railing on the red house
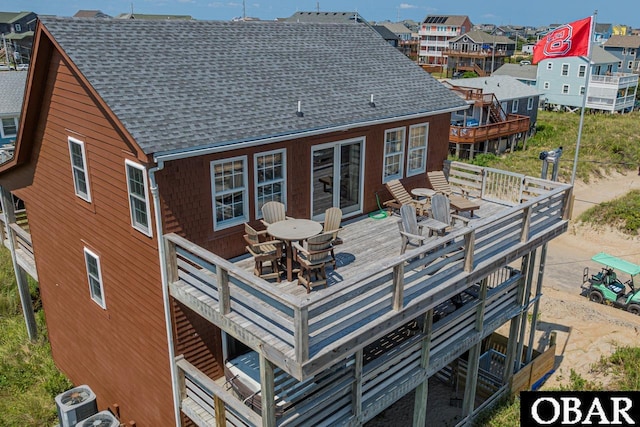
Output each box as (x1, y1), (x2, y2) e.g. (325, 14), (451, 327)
(165, 161), (571, 380)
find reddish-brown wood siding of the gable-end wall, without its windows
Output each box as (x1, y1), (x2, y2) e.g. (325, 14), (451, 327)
(15, 54), (174, 426)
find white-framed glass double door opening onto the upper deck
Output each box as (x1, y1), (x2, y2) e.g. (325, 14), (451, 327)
(311, 139), (364, 220)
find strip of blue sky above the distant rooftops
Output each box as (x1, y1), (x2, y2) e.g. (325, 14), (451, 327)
(6, 0), (640, 28)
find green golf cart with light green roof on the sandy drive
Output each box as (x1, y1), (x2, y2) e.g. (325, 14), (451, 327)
(582, 252), (640, 315)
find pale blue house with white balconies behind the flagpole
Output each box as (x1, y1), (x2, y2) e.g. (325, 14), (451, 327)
(537, 46), (638, 113)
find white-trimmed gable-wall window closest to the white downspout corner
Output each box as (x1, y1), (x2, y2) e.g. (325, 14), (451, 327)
(124, 159), (152, 237)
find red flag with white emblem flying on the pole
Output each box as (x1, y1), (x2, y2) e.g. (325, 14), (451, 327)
(533, 16), (592, 64)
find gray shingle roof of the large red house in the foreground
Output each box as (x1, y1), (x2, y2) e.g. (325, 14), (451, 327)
(37, 17), (465, 154)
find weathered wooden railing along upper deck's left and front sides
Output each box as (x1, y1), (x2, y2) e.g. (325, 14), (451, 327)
(165, 165), (571, 378)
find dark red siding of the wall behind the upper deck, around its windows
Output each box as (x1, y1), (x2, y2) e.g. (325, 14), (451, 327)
(157, 114), (450, 258)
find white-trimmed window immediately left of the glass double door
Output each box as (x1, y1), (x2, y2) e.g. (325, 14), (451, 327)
(253, 150), (287, 218)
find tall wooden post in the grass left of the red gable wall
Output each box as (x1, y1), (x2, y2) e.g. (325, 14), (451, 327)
(2, 187), (38, 341)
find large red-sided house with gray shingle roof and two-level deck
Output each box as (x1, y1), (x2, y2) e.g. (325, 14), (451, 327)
(0, 17), (571, 426)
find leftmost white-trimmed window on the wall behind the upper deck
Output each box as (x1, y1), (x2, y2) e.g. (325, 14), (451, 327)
(211, 156), (249, 230)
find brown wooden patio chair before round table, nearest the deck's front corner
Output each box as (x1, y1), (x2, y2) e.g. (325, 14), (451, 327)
(293, 233), (335, 293)
